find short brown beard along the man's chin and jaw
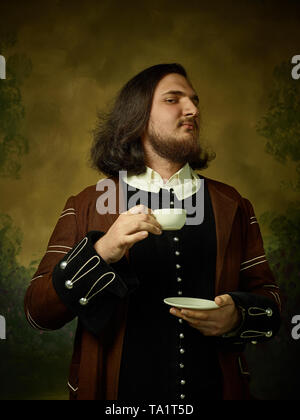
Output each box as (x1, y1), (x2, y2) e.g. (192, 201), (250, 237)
(148, 123), (202, 164)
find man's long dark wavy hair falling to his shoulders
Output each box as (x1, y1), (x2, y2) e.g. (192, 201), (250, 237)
(90, 63), (215, 176)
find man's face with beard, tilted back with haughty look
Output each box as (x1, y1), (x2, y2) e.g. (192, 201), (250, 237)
(143, 73), (200, 163)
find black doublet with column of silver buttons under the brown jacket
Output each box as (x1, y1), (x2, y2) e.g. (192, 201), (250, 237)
(118, 176), (222, 402)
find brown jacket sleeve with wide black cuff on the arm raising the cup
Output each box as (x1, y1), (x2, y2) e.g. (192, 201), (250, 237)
(24, 197), (136, 335)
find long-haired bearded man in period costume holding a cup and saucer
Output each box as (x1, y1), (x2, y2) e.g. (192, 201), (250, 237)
(25, 64), (280, 402)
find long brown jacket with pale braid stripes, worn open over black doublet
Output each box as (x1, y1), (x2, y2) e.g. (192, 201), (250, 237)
(25, 178), (280, 400)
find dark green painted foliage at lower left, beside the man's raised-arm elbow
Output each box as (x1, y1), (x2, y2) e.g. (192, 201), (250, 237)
(0, 215), (74, 400)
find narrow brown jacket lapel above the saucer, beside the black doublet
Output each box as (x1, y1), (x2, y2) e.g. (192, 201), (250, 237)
(204, 177), (238, 295)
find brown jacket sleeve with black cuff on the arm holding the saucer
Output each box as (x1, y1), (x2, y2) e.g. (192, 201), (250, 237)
(224, 198), (281, 344)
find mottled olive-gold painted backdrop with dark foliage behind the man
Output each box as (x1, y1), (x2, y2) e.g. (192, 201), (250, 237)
(0, 0), (300, 399)
